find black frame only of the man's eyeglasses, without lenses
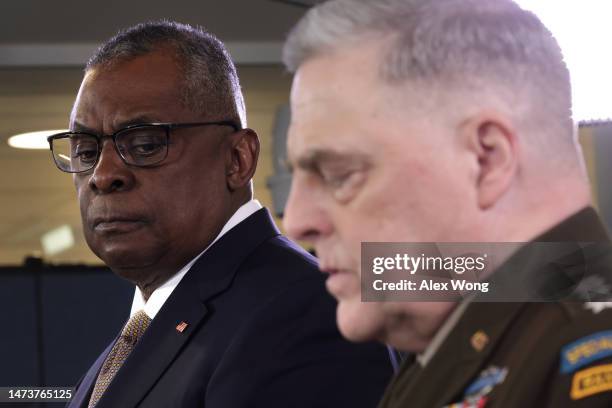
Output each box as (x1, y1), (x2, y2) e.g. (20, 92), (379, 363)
(47, 120), (242, 174)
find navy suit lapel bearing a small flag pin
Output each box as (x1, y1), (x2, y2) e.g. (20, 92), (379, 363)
(94, 209), (279, 408)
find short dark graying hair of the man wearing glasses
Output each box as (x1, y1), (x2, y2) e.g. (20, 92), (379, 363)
(85, 20), (246, 126)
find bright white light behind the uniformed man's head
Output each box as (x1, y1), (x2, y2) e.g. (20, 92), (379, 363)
(516, 0), (612, 123)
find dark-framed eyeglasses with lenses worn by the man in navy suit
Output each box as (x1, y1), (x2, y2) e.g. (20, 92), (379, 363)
(47, 120), (241, 173)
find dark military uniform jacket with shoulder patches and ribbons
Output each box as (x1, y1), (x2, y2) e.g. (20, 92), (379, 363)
(380, 208), (612, 408)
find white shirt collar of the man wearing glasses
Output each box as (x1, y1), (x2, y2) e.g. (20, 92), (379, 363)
(130, 200), (263, 319)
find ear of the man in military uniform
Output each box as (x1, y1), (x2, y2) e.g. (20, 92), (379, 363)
(460, 113), (519, 210)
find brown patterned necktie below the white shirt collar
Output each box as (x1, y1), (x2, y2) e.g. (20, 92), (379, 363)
(89, 310), (151, 408)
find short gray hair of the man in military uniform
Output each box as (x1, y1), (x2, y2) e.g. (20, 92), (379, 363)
(283, 0), (575, 152)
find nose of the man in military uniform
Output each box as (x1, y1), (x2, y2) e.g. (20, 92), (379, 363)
(283, 175), (331, 244)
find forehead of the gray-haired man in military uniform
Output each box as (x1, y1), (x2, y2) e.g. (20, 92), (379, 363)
(288, 43), (436, 159)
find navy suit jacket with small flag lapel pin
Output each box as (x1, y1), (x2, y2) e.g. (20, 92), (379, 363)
(69, 209), (392, 408)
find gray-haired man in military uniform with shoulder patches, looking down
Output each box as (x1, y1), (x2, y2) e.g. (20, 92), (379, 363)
(284, 0), (612, 408)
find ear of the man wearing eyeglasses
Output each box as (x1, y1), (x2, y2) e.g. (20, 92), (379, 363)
(225, 129), (259, 191)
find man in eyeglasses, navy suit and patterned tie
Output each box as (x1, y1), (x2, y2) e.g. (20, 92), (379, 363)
(49, 22), (391, 408)
